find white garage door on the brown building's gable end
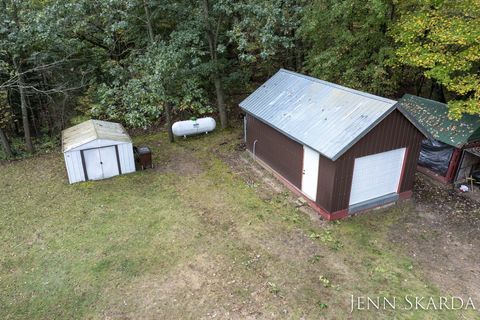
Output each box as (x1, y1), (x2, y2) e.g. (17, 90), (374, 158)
(349, 148), (405, 206)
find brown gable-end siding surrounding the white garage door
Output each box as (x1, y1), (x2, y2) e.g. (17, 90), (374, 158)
(328, 110), (423, 212)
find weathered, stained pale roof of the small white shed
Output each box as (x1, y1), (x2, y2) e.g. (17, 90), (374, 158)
(62, 120), (132, 152)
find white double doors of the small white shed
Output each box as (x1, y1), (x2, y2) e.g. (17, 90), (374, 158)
(83, 146), (120, 180)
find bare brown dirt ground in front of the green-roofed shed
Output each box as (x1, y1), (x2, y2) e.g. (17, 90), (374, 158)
(390, 174), (480, 301)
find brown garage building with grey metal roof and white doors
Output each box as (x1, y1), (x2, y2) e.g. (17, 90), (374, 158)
(240, 69), (423, 220)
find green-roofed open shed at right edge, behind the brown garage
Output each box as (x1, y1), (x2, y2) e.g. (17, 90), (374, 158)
(398, 94), (480, 184)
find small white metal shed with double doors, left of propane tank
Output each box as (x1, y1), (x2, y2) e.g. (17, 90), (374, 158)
(62, 120), (135, 183)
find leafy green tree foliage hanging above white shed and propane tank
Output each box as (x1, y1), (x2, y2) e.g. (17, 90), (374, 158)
(90, 34), (211, 136)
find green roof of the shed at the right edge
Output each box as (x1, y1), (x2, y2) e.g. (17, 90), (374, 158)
(397, 94), (480, 148)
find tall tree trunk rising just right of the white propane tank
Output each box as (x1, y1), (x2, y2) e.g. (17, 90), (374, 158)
(203, 0), (228, 129)
